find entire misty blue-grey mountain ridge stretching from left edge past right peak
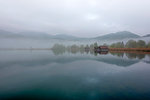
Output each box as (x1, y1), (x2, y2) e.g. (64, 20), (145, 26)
(0, 30), (141, 41)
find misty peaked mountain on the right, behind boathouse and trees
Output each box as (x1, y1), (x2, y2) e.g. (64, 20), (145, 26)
(94, 31), (140, 40)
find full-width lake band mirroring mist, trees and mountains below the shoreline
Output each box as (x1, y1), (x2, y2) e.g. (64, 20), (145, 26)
(0, 49), (150, 68)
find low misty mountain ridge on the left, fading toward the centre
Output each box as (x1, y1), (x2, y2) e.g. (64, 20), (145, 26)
(0, 30), (80, 40)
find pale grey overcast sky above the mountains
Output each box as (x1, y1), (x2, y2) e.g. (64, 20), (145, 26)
(0, 0), (150, 37)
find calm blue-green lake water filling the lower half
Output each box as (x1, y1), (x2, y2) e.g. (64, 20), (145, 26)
(0, 50), (150, 100)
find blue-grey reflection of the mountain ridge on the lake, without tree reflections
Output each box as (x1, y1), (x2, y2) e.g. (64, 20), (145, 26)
(0, 51), (139, 67)
